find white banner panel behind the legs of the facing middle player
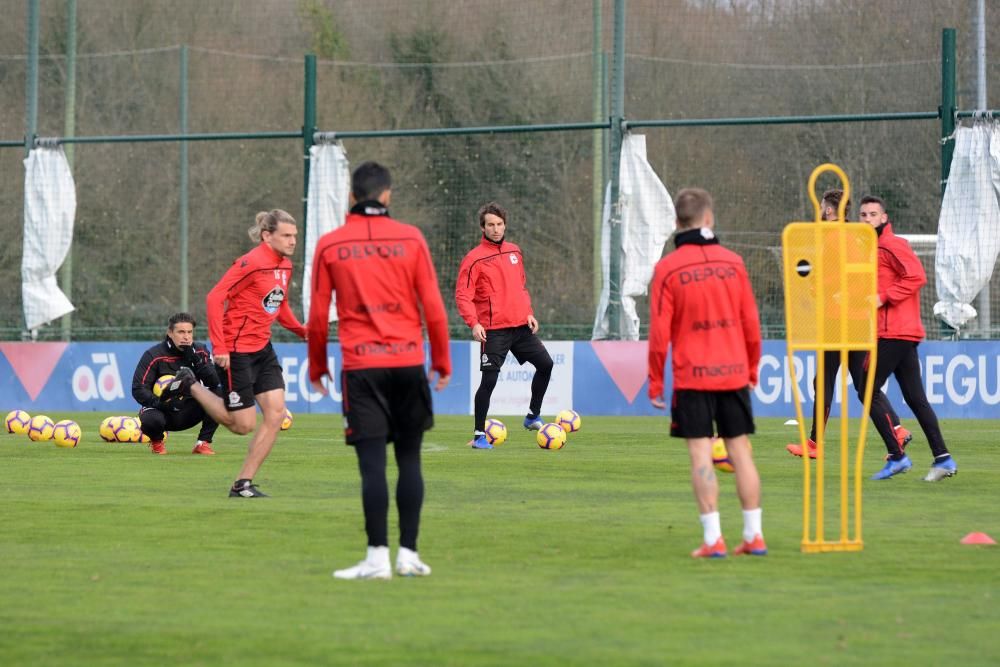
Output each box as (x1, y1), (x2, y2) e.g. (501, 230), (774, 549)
(469, 341), (573, 415)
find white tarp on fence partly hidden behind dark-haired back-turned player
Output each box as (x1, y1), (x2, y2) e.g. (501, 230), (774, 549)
(302, 143), (351, 322)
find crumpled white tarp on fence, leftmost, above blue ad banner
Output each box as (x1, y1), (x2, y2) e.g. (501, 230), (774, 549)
(21, 147), (76, 331)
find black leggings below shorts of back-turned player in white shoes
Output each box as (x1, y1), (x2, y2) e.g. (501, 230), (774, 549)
(354, 431), (424, 551)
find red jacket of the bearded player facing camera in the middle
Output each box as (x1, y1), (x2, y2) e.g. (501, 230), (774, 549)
(455, 236), (533, 330)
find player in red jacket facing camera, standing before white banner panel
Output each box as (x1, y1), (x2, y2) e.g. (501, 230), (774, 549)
(455, 202), (552, 449)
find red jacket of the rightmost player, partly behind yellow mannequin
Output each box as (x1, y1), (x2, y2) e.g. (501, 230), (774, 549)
(876, 222), (927, 341)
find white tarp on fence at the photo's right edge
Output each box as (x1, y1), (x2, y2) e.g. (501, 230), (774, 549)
(934, 122), (1000, 329)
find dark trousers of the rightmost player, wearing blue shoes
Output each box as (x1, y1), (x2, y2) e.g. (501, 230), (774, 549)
(872, 338), (948, 459)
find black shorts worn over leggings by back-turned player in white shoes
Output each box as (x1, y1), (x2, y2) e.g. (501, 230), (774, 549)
(340, 366), (434, 445)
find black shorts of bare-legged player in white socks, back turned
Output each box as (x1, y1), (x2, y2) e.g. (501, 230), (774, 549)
(670, 387), (754, 438)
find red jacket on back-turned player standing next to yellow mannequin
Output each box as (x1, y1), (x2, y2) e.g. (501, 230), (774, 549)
(649, 228), (760, 398)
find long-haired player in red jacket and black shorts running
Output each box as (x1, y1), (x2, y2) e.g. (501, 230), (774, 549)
(170, 209), (306, 498)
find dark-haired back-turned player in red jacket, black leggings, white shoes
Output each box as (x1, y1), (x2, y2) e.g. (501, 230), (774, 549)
(309, 162), (451, 579)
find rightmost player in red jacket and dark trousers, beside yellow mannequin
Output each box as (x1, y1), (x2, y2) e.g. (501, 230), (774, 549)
(861, 196), (958, 482)
